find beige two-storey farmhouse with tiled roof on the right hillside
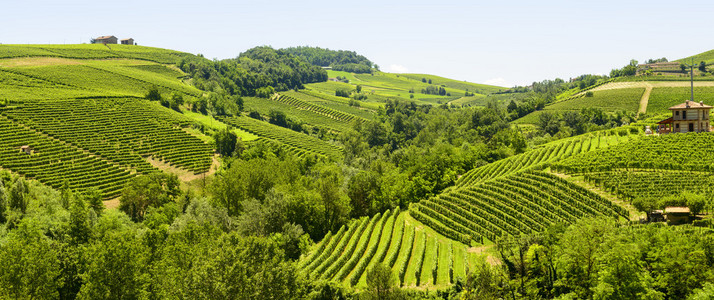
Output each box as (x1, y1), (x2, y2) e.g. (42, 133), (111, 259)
(657, 100), (712, 134)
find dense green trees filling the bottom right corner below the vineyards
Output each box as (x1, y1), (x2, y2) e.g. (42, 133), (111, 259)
(460, 219), (714, 299)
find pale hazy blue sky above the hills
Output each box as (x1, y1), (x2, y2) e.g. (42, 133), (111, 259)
(0, 0), (714, 86)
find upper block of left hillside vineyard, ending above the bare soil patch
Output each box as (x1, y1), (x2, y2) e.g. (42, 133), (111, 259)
(0, 98), (213, 173)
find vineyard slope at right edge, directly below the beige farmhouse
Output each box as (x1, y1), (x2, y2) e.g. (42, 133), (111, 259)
(552, 132), (714, 174)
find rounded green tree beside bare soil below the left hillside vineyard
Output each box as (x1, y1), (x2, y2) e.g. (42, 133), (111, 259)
(119, 172), (181, 221)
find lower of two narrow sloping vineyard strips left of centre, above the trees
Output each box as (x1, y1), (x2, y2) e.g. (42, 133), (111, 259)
(218, 116), (342, 159)
